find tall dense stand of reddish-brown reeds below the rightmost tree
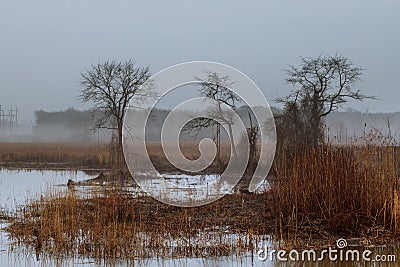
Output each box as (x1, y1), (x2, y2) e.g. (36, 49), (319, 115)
(271, 145), (400, 246)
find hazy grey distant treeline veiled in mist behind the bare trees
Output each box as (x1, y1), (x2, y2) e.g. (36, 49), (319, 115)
(29, 107), (400, 143)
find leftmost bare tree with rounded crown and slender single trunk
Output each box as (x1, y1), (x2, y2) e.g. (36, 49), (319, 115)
(79, 59), (151, 154)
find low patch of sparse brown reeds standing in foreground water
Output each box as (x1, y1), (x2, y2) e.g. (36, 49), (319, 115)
(7, 187), (271, 259)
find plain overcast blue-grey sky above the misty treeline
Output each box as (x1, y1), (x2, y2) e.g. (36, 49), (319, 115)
(0, 0), (400, 121)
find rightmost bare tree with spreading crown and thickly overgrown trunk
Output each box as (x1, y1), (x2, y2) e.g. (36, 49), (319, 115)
(277, 55), (374, 146)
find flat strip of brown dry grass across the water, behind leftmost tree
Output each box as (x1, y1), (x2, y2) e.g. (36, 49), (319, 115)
(0, 143), (230, 172)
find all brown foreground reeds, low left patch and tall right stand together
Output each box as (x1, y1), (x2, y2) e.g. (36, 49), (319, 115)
(4, 141), (400, 258)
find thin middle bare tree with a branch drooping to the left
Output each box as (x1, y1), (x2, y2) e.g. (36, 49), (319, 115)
(183, 71), (242, 168)
